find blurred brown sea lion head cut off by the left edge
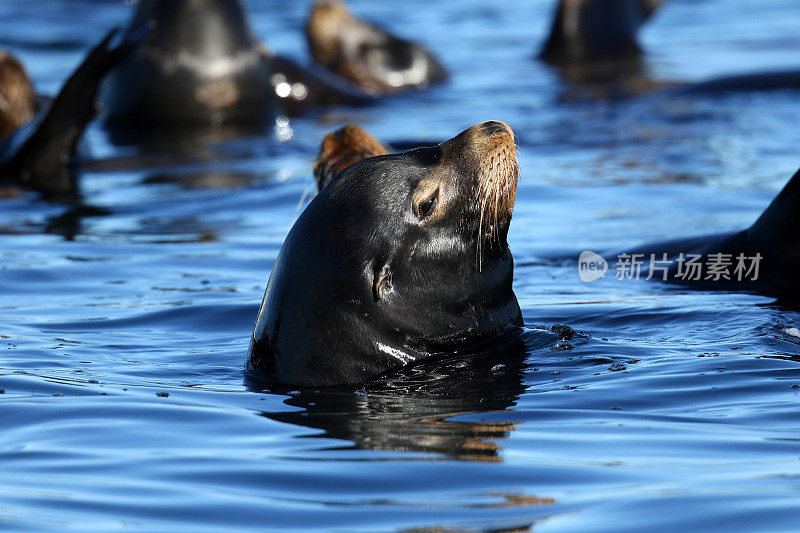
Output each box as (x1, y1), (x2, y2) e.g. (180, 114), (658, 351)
(0, 50), (36, 139)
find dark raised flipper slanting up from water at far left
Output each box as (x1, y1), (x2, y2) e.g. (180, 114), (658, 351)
(0, 29), (142, 196)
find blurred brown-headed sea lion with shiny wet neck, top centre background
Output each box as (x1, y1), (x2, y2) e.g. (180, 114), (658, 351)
(306, 0), (447, 94)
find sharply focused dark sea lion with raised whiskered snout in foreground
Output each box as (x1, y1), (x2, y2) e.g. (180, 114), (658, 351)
(246, 121), (522, 385)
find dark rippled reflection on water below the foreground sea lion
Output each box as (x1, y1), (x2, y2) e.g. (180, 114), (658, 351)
(247, 330), (554, 462)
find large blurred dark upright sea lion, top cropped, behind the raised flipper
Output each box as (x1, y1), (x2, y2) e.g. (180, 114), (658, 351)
(103, 0), (273, 127)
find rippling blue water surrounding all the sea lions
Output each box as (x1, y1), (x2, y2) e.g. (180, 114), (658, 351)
(0, 0), (800, 532)
